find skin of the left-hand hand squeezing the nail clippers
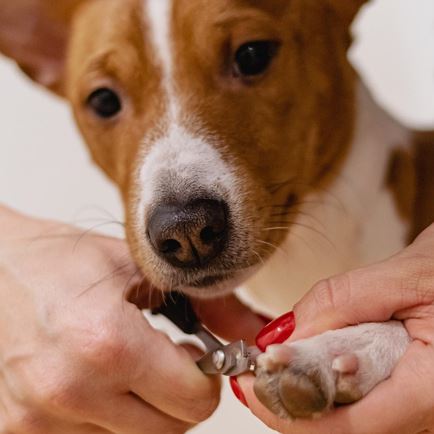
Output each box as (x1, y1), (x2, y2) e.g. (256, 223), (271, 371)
(0, 206), (263, 434)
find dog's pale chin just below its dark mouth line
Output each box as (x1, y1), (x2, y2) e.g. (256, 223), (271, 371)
(177, 267), (256, 299)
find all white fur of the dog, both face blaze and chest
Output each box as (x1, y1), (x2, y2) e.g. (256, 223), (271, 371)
(142, 5), (408, 313)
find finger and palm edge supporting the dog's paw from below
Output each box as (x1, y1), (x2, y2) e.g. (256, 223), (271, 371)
(238, 341), (434, 434)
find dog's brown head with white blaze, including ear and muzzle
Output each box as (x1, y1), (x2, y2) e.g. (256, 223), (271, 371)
(0, 0), (370, 295)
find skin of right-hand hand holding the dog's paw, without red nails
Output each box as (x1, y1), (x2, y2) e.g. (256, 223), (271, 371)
(239, 225), (434, 434)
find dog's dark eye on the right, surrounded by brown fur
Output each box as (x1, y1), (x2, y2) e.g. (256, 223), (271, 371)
(235, 41), (278, 77)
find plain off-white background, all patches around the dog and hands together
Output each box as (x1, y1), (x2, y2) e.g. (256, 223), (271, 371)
(0, 0), (434, 434)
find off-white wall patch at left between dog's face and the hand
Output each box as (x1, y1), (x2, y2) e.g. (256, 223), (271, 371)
(0, 57), (122, 232)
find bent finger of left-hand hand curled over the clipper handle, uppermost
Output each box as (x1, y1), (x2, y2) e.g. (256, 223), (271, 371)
(125, 306), (220, 423)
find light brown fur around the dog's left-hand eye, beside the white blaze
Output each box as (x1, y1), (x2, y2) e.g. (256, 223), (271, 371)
(66, 0), (154, 190)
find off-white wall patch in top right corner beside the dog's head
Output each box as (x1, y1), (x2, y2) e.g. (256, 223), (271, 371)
(351, 0), (434, 128)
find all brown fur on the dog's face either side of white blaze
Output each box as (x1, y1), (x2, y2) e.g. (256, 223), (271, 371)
(5, 0), (410, 292)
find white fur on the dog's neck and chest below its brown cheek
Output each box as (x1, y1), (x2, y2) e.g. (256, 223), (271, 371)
(242, 85), (409, 314)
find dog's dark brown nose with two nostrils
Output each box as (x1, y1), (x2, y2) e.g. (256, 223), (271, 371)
(148, 199), (228, 268)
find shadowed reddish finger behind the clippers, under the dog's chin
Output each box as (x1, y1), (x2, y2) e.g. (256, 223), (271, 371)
(192, 295), (268, 343)
